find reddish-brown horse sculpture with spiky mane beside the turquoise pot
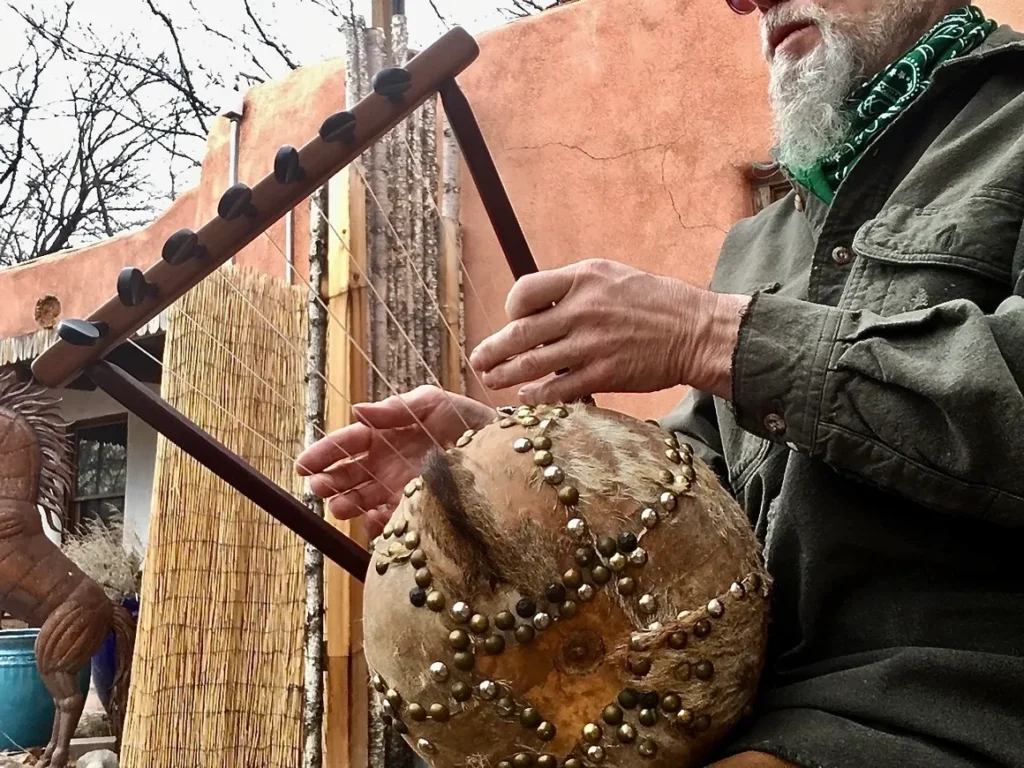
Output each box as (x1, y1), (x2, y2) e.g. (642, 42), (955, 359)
(0, 373), (135, 768)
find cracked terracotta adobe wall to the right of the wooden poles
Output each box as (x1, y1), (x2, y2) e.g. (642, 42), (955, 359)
(460, 0), (1024, 418)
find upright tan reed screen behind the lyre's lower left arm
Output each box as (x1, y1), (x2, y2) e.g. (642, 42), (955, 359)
(122, 266), (306, 768)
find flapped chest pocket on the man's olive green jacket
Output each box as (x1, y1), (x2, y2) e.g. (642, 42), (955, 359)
(843, 189), (1024, 315)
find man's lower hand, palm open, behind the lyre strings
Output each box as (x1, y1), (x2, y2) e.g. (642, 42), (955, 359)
(295, 386), (497, 537)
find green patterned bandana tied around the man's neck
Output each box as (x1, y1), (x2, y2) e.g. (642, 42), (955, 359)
(790, 6), (997, 204)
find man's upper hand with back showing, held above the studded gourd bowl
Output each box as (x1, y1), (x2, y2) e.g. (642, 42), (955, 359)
(470, 259), (750, 404)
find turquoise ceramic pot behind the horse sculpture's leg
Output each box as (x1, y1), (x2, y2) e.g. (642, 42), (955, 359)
(0, 630), (89, 752)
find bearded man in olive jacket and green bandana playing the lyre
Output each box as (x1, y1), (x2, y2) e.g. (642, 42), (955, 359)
(300, 0), (1024, 768)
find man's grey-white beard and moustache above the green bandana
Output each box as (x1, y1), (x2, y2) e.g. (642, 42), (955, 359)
(761, 0), (932, 168)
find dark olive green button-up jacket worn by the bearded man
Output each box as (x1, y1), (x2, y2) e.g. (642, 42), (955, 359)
(663, 27), (1024, 768)
